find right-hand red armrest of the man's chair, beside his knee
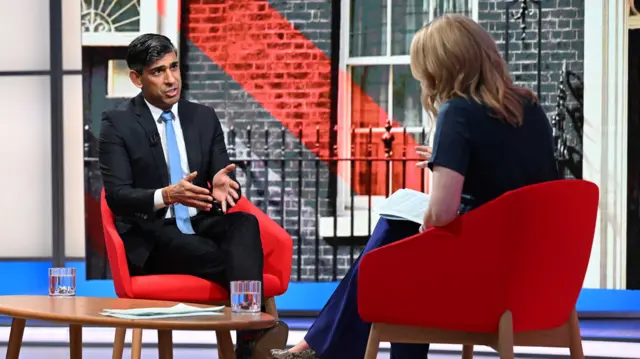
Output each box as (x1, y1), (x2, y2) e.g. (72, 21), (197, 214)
(230, 196), (293, 295)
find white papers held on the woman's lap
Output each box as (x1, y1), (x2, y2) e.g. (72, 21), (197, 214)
(375, 188), (429, 224)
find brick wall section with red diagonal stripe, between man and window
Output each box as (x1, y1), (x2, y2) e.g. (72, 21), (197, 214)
(182, 0), (340, 280)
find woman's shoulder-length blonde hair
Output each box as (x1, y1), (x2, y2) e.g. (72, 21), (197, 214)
(410, 15), (538, 126)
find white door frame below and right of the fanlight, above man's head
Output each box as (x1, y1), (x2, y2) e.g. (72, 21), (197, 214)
(82, 0), (159, 46)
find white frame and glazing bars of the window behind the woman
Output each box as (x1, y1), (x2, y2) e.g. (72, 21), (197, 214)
(336, 0), (478, 215)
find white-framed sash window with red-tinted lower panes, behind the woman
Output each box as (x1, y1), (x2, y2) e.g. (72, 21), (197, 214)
(338, 0), (477, 204)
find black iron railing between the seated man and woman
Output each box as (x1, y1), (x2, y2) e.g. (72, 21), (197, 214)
(226, 124), (428, 281)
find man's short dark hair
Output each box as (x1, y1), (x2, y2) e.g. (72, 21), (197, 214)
(127, 34), (177, 74)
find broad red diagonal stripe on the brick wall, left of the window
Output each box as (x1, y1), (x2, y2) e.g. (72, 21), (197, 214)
(188, 0), (331, 156)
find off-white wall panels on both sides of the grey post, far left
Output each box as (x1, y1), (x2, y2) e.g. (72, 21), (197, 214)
(0, 0), (84, 259)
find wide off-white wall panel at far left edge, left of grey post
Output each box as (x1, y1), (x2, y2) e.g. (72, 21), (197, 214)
(0, 0), (52, 257)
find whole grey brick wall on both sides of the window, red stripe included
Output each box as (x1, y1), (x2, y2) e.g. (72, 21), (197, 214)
(182, 0), (584, 280)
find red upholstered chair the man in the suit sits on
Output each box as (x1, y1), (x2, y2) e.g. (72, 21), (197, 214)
(100, 189), (293, 359)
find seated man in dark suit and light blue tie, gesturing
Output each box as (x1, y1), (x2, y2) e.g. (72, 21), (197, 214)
(99, 34), (287, 359)
